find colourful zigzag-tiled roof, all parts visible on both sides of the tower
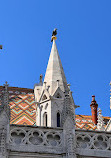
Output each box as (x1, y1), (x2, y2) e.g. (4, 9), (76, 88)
(0, 86), (110, 130)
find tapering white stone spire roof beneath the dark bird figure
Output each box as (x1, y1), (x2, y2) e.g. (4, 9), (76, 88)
(44, 39), (67, 95)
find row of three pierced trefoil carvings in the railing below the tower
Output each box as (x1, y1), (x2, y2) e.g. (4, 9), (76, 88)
(10, 128), (62, 147)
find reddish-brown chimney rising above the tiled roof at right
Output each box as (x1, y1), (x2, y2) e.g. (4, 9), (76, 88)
(90, 95), (98, 125)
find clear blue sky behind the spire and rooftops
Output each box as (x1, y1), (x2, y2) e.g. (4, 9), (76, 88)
(0, 0), (111, 116)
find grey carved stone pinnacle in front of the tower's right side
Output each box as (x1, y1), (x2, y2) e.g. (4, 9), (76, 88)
(62, 95), (77, 158)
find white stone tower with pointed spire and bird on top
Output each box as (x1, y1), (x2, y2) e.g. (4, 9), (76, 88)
(34, 30), (74, 127)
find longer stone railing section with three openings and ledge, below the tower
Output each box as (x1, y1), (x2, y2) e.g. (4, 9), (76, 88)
(9, 125), (63, 153)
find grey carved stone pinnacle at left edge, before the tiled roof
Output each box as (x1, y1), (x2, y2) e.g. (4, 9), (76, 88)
(0, 82), (10, 158)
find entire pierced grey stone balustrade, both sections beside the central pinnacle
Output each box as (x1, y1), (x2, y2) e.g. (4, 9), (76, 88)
(9, 125), (111, 158)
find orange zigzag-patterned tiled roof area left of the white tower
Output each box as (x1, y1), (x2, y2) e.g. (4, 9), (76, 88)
(0, 86), (35, 125)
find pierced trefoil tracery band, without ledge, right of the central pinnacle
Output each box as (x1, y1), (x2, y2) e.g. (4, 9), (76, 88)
(76, 132), (111, 151)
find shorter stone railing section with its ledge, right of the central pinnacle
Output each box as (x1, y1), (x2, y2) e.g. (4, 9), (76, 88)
(76, 130), (111, 157)
